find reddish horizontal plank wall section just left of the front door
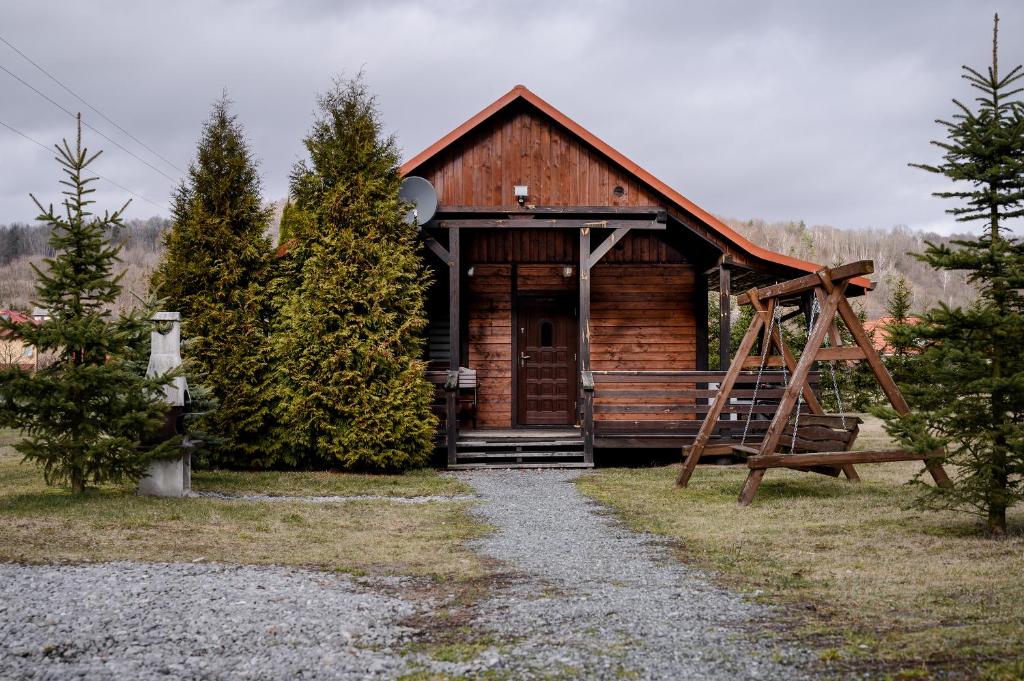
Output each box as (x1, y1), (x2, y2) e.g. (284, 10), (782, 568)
(465, 264), (512, 428)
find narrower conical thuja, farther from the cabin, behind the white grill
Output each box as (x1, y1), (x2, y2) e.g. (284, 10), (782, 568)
(151, 97), (272, 466)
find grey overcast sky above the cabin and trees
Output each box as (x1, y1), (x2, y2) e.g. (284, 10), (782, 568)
(0, 0), (1024, 232)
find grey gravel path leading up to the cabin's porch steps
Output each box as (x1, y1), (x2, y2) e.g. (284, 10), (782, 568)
(454, 470), (808, 679)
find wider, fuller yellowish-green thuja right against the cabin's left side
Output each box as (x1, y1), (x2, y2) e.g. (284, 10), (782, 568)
(273, 78), (435, 470)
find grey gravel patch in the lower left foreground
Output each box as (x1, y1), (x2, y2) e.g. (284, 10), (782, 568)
(0, 562), (414, 680)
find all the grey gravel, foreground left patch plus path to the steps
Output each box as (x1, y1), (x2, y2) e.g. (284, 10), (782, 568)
(0, 471), (809, 680)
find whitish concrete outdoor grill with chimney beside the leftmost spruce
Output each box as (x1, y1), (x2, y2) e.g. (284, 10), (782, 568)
(138, 312), (191, 497)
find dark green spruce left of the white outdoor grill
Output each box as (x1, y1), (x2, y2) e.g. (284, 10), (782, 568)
(0, 119), (172, 494)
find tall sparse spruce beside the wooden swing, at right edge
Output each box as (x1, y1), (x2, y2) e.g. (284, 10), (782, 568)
(888, 17), (1024, 535)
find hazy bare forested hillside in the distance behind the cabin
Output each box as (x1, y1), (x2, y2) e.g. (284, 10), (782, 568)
(0, 213), (974, 318)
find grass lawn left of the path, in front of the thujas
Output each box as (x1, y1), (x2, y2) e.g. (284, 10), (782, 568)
(0, 431), (487, 580)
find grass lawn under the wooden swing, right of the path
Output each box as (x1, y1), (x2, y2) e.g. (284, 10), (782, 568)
(579, 420), (1024, 679)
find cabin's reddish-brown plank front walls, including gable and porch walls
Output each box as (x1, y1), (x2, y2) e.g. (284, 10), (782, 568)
(416, 100), (697, 428)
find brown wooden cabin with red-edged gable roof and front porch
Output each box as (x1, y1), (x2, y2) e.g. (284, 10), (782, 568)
(401, 85), (869, 467)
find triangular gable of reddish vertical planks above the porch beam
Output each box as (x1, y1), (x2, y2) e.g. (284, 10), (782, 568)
(417, 104), (665, 206)
